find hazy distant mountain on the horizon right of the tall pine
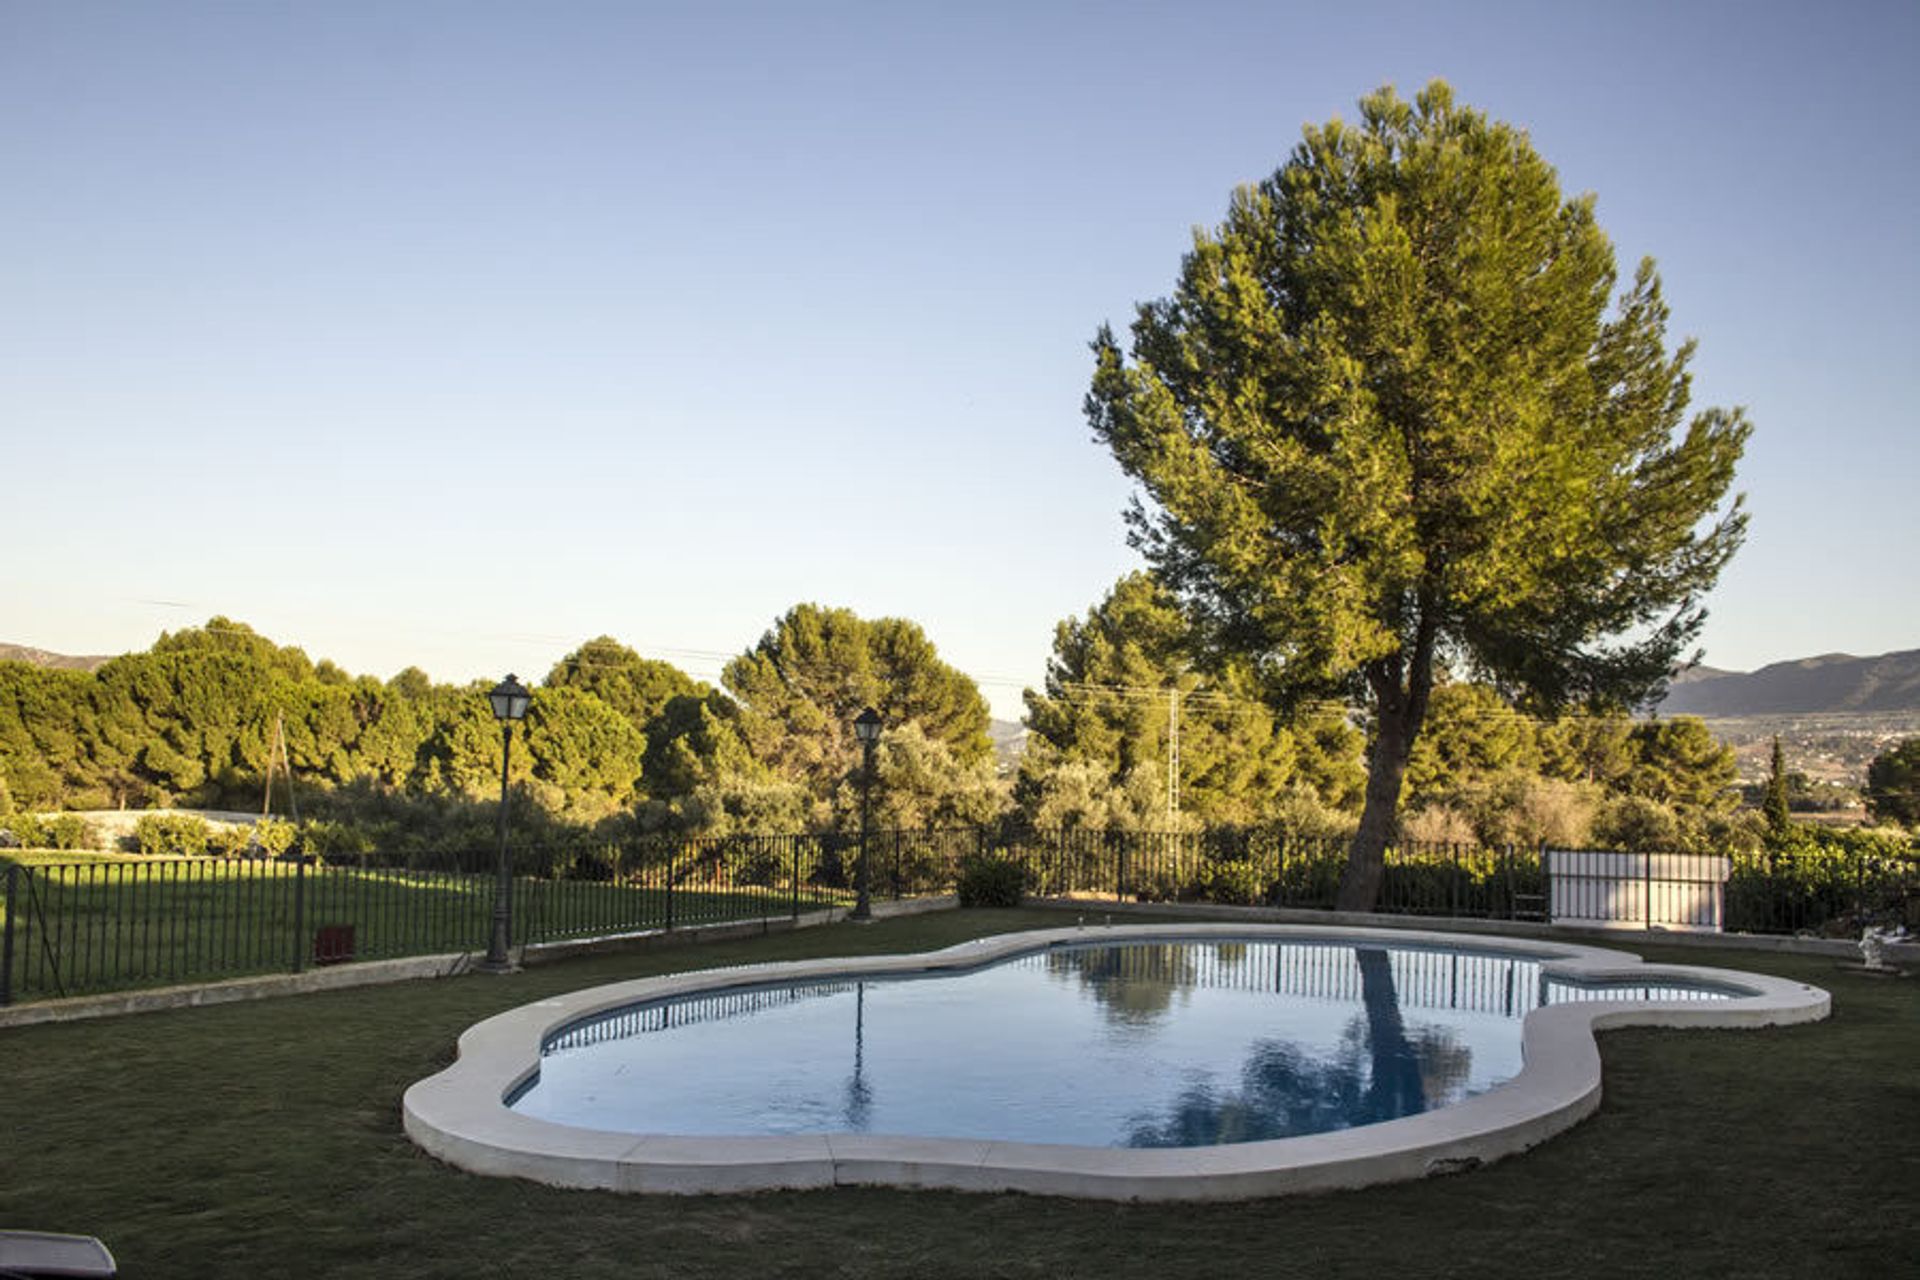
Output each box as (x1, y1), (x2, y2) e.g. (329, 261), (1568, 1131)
(1659, 649), (1920, 716)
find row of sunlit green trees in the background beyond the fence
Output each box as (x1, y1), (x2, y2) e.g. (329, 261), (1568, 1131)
(0, 587), (1766, 852)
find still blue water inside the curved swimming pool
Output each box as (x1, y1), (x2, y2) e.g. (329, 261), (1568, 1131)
(509, 940), (1738, 1148)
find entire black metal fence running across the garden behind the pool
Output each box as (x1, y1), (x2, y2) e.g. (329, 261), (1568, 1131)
(0, 827), (1920, 1004)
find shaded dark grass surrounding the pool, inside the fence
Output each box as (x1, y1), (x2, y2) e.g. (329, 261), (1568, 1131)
(0, 912), (1920, 1280)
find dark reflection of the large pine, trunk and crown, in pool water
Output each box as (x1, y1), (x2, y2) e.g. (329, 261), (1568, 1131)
(1127, 948), (1473, 1148)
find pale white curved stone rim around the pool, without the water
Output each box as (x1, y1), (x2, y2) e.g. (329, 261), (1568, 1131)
(403, 925), (1830, 1199)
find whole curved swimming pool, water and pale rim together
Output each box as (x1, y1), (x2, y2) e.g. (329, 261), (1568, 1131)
(405, 925), (1826, 1199)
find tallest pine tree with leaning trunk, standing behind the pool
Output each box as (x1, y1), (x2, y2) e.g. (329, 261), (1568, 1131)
(1087, 81), (1749, 910)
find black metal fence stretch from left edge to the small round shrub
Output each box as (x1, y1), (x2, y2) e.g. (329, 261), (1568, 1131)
(0, 831), (960, 1004)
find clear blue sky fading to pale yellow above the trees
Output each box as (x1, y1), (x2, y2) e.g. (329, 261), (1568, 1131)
(0, 0), (1920, 716)
